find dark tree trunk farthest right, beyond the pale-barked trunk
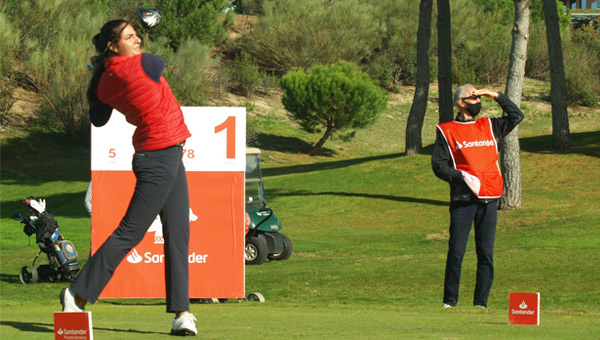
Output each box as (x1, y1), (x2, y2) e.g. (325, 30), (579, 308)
(543, 0), (571, 150)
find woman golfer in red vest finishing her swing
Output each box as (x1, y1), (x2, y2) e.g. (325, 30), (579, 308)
(60, 20), (197, 335)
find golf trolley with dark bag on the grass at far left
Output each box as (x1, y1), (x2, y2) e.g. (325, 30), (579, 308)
(12, 196), (80, 284)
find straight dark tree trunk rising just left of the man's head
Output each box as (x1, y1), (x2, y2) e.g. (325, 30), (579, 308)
(437, 0), (454, 123)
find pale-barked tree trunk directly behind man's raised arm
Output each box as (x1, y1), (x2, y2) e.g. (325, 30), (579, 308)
(498, 0), (529, 210)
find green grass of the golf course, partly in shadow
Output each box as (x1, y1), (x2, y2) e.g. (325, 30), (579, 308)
(0, 92), (600, 339)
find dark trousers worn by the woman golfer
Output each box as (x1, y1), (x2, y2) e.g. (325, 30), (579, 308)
(71, 146), (190, 313)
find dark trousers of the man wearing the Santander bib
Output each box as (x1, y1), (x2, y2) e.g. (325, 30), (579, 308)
(444, 200), (498, 307)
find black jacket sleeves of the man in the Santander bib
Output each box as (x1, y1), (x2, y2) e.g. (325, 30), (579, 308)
(431, 93), (523, 201)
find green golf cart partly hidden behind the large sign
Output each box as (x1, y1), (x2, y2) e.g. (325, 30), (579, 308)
(245, 148), (293, 264)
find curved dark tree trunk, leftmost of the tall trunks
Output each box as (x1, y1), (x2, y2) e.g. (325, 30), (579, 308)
(406, 0), (433, 156)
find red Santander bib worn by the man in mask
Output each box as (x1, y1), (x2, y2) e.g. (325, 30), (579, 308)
(438, 118), (504, 199)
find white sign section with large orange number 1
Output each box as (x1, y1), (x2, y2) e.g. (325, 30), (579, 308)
(182, 107), (246, 172)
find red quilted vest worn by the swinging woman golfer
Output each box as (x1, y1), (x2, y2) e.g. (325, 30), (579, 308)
(98, 54), (191, 151)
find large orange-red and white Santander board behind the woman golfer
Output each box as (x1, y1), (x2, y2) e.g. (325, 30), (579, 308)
(92, 107), (246, 298)
